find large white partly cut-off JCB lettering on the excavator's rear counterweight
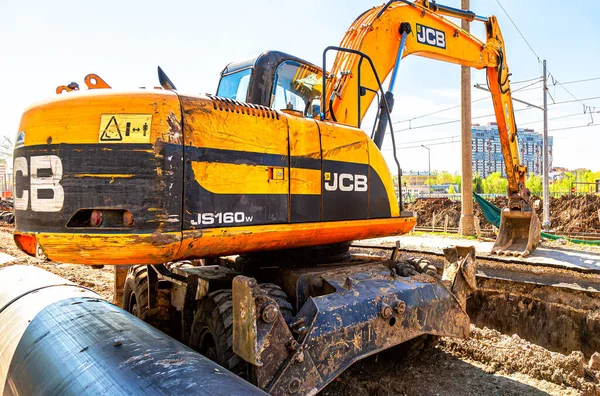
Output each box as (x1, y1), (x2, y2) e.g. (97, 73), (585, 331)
(13, 155), (65, 212)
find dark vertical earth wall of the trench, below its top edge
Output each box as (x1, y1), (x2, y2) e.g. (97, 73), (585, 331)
(467, 278), (600, 358)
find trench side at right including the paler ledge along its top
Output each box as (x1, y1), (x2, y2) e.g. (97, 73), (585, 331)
(356, 249), (600, 358)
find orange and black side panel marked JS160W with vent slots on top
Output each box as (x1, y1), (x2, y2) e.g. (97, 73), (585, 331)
(181, 96), (290, 229)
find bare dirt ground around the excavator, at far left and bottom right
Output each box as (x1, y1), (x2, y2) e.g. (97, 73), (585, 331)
(0, 225), (600, 396)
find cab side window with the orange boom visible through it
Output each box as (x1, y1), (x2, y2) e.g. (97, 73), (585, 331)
(271, 61), (323, 117)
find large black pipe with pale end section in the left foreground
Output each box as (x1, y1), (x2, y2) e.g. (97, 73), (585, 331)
(0, 266), (264, 395)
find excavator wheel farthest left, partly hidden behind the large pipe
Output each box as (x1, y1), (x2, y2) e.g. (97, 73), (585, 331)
(123, 265), (171, 334)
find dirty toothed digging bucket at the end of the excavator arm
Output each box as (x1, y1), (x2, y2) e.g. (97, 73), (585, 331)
(492, 208), (541, 257)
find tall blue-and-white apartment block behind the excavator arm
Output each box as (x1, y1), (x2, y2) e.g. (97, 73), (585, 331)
(471, 122), (553, 177)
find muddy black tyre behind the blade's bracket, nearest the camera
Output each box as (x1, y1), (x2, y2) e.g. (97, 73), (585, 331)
(189, 283), (292, 378)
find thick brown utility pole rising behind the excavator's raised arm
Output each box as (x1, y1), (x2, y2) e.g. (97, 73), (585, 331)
(460, 0), (475, 235)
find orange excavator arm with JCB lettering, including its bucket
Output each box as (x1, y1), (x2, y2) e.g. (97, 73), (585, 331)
(324, 0), (540, 255)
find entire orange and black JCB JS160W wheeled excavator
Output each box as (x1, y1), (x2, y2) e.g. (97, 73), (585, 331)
(14, 0), (539, 394)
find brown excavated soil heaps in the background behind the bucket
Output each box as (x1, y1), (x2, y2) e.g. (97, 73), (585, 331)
(406, 194), (600, 232)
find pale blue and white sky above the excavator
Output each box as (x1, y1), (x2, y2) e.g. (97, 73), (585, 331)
(0, 0), (600, 171)
